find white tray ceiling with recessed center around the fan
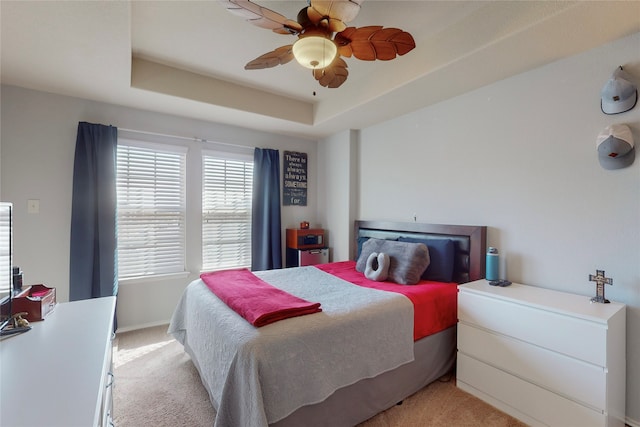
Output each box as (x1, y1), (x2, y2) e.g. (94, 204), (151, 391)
(0, 0), (640, 139)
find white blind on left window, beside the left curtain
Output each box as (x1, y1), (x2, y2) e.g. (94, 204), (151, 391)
(117, 139), (187, 279)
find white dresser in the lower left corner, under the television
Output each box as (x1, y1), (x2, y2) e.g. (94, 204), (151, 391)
(0, 297), (116, 427)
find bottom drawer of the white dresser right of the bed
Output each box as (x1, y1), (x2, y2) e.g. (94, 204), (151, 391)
(457, 353), (606, 427)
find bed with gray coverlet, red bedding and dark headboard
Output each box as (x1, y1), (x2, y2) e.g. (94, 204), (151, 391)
(169, 221), (486, 427)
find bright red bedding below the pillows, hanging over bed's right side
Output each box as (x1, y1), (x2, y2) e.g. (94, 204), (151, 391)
(316, 261), (458, 341)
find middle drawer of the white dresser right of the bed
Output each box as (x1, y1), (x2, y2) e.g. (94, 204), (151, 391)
(458, 323), (607, 410)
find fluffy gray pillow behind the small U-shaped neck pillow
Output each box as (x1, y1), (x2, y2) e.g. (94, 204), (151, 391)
(356, 239), (430, 285)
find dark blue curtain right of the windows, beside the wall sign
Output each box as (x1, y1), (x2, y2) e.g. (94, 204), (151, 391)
(251, 148), (282, 271)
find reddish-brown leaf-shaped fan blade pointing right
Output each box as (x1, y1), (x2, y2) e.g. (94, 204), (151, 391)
(334, 25), (416, 61)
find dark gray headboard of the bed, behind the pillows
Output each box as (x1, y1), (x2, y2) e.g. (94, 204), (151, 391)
(352, 221), (487, 283)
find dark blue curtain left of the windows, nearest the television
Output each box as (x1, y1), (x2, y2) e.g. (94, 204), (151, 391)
(69, 122), (118, 301)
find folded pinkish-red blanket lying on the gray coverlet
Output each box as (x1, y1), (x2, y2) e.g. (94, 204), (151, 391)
(200, 269), (322, 327)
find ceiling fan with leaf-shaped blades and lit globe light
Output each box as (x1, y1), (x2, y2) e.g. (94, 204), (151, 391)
(219, 0), (416, 88)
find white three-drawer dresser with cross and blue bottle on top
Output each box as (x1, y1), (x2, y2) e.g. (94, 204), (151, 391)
(457, 279), (626, 427)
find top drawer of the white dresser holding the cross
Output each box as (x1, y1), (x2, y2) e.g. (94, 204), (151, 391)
(458, 292), (607, 366)
